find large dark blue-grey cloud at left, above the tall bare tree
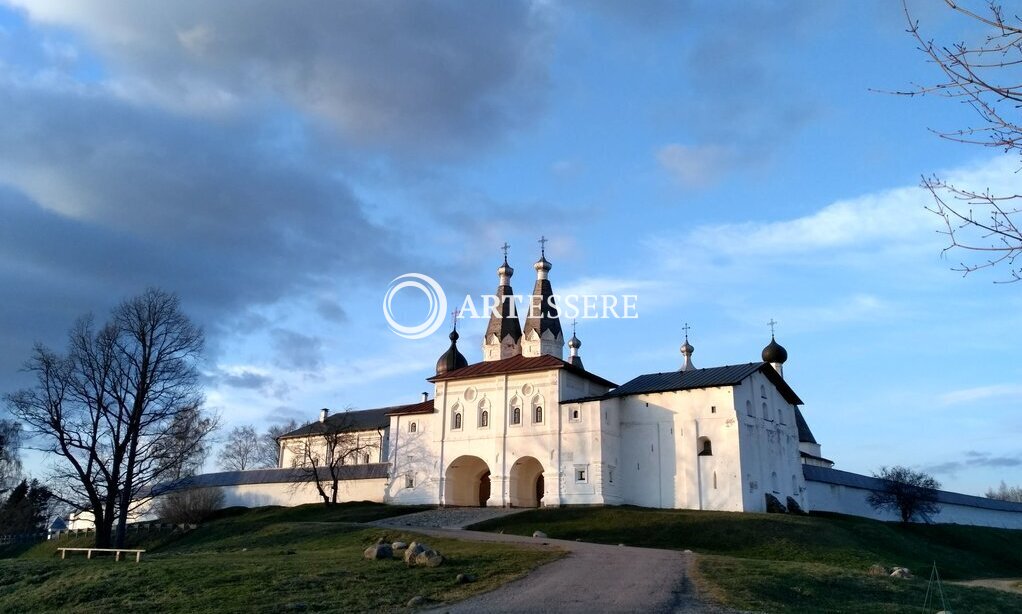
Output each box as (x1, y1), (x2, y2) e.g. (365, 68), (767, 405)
(0, 77), (400, 389)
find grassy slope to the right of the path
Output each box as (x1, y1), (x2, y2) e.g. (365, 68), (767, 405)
(471, 507), (1022, 612)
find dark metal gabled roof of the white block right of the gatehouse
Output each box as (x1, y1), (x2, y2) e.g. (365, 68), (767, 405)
(605, 363), (802, 406)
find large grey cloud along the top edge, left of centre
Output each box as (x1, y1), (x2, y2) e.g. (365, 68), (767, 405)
(9, 0), (549, 155)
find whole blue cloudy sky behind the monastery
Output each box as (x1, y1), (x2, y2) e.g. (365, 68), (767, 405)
(0, 0), (1022, 494)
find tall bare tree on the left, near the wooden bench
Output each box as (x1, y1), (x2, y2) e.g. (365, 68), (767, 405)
(7, 288), (216, 547)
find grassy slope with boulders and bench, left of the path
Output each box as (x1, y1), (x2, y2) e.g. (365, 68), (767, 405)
(0, 504), (560, 612)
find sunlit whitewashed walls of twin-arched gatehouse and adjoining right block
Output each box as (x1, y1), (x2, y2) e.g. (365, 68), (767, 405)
(386, 359), (806, 512)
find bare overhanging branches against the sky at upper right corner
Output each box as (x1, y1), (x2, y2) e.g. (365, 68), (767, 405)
(897, 0), (1022, 282)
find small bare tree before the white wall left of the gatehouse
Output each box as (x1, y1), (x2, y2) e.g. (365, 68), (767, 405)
(284, 413), (383, 506)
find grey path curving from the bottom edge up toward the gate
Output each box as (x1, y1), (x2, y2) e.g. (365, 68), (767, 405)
(374, 517), (732, 614)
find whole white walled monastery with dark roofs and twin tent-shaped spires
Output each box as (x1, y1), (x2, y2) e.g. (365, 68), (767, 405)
(144, 242), (1022, 528)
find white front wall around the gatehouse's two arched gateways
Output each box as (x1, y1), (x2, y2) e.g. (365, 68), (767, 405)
(385, 369), (606, 507)
